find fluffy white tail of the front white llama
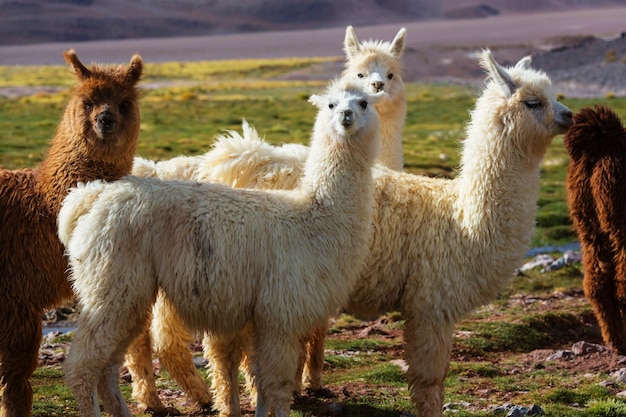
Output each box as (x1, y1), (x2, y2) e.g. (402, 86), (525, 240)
(57, 180), (106, 247)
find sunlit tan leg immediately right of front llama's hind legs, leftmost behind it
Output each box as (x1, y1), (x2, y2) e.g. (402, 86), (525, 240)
(125, 312), (179, 416)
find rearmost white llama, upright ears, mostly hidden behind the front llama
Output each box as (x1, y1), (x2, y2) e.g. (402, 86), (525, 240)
(126, 26), (406, 414)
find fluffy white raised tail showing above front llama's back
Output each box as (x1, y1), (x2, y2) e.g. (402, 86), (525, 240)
(199, 120), (308, 189)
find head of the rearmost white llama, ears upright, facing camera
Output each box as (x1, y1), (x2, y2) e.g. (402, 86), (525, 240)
(342, 26), (406, 100)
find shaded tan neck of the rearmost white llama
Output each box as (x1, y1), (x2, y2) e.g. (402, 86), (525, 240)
(376, 86), (406, 171)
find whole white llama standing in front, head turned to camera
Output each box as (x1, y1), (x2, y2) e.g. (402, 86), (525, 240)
(58, 82), (385, 417)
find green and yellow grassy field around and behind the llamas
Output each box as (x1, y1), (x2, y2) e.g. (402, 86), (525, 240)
(0, 59), (626, 417)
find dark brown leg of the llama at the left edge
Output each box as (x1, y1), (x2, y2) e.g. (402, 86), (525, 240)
(0, 309), (41, 417)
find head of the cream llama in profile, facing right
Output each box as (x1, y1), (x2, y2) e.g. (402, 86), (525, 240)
(471, 50), (572, 164)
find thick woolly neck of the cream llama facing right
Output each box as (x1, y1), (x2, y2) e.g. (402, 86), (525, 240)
(454, 116), (539, 286)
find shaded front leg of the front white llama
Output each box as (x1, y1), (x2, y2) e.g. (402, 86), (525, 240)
(254, 329), (302, 417)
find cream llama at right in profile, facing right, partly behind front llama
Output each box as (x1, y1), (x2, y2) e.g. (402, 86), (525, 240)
(147, 50), (572, 417)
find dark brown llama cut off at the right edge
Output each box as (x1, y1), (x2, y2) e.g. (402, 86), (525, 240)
(564, 106), (626, 355)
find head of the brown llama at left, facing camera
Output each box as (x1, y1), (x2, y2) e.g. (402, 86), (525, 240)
(62, 49), (143, 162)
